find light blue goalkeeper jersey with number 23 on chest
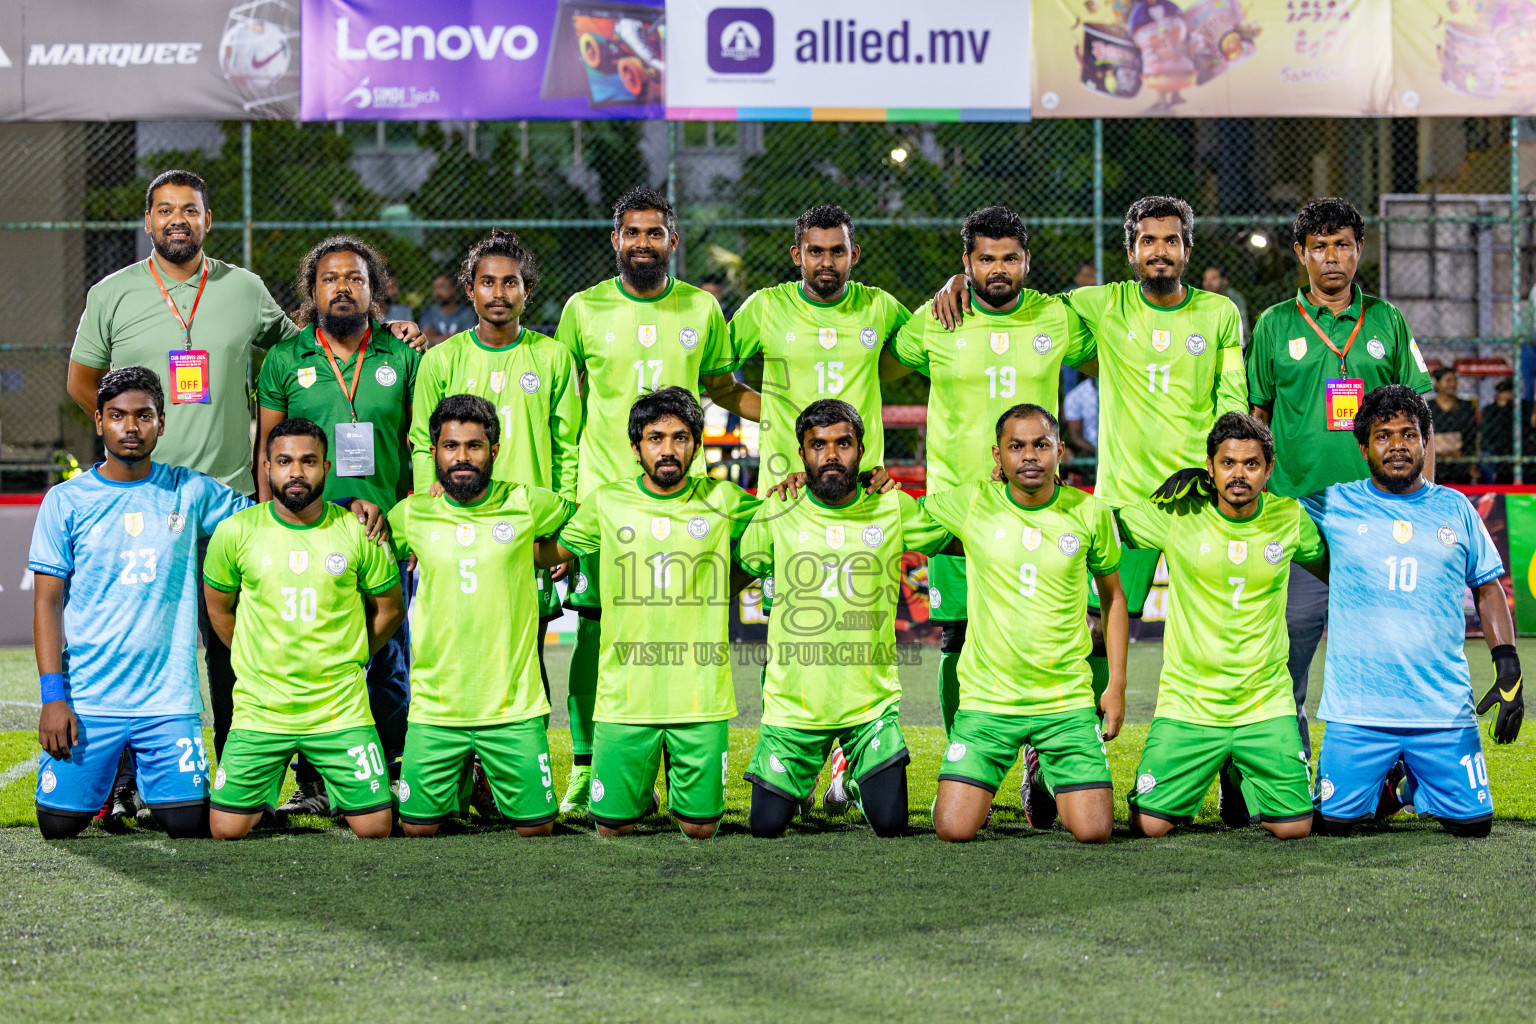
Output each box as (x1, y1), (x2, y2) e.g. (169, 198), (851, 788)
(28, 462), (250, 717)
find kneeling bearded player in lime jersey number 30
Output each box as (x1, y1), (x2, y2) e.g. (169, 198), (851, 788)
(203, 419), (406, 840)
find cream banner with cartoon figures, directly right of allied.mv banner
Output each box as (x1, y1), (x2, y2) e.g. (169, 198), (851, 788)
(1034, 0), (1395, 117)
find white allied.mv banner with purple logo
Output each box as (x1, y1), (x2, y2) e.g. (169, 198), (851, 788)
(667, 0), (1031, 121)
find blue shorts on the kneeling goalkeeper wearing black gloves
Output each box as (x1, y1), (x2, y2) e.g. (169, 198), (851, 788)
(1318, 722), (1493, 821)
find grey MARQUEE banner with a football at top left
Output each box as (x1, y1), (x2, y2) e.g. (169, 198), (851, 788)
(0, 0), (300, 121)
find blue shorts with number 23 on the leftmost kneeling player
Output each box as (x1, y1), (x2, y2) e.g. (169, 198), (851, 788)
(37, 715), (209, 815)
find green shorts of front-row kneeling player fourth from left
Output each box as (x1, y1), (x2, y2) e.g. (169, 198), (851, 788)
(591, 720), (731, 829)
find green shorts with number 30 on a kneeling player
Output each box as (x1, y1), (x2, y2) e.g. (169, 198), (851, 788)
(214, 725), (392, 814)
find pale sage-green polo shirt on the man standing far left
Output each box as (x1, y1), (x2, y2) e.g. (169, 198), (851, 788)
(69, 256), (298, 494)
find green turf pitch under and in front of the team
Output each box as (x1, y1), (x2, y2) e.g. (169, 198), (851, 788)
(0, 645), (1536, 1022)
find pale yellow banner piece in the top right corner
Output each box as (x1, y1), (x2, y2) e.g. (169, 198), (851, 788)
(1392, 0), (1536, 117)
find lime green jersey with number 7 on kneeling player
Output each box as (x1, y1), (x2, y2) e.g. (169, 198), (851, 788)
(1118, 494), (1324, 726)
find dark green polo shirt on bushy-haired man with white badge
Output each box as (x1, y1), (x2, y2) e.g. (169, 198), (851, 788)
(257, 324), (421, 511)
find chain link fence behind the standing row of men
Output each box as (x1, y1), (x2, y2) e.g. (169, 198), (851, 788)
(0, 118), (1536, 490)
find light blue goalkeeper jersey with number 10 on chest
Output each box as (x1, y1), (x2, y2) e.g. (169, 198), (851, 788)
(1303, 479), (1504, 728)
